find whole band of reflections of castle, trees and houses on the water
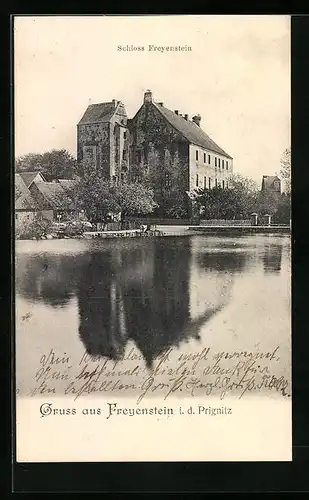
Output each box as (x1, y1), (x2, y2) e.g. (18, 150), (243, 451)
(16, 237), (282, 366)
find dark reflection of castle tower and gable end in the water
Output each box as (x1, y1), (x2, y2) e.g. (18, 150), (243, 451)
(77, 238), (194, 364)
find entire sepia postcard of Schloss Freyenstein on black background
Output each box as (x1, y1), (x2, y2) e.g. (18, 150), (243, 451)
(13, 15), (292, 462)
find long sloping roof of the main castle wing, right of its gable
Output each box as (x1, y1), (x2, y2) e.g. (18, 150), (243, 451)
(153, 102), (232, 159)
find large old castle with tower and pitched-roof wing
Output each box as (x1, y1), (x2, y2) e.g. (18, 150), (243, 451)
(77, 90), (233, 214)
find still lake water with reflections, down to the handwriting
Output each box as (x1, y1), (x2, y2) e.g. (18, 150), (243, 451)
(15, 235), (291, 396)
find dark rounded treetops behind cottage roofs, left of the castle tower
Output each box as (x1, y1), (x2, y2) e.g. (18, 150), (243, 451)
(15, 149), (76, 180)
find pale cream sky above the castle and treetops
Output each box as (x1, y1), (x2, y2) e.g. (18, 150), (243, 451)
(14, 15), (291, 182)
